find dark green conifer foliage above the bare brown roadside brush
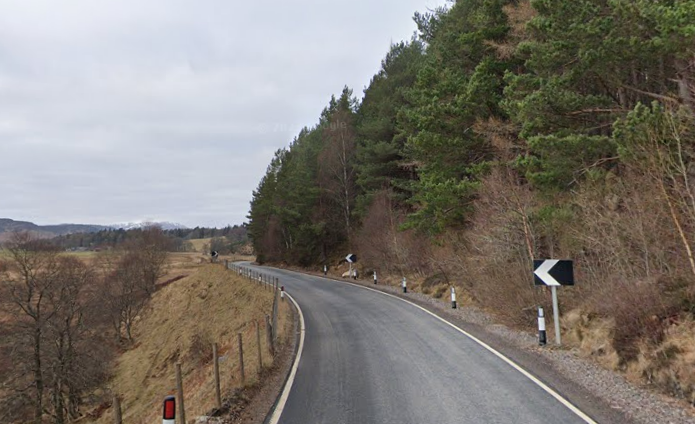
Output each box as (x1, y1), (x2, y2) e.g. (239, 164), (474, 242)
(249, 0), (695, 264)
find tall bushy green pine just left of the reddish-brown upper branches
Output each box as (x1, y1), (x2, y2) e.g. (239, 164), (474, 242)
(399, 0), (509, 233)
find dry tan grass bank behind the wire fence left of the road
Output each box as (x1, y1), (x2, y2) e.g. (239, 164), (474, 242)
(90, 264), (291, 423)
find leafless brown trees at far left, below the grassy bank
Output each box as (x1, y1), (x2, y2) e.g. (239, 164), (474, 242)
(0, 228), (169, 424)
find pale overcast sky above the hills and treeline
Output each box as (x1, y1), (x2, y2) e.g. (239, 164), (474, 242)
(0, 0), (445, 226)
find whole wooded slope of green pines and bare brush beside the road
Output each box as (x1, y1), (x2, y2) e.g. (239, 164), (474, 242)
(248, 0), (695, 402)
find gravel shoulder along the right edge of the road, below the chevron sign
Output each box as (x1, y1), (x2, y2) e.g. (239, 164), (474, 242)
(284, 269), (695, 424)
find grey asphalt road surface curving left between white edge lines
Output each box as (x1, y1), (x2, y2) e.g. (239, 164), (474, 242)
(249, 268), (600, 424)
